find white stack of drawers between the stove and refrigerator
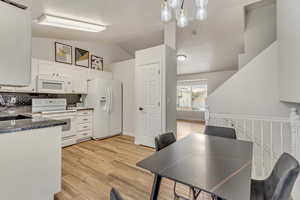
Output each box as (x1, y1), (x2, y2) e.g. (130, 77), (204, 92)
(76, 110), (93, 143)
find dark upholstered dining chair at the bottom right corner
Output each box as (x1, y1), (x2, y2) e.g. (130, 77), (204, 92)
(251, 153), (300, 200)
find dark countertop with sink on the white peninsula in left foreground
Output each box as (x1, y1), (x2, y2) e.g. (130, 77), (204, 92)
(0, 117), (66, 134)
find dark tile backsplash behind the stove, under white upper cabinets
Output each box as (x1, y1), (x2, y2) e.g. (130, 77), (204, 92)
(0, 92), (81, 106)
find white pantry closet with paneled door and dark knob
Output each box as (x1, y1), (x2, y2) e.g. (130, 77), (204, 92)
(135, 45), (177, 147)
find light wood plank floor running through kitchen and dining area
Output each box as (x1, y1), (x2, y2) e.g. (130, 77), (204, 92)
(55, 121), (205, 200)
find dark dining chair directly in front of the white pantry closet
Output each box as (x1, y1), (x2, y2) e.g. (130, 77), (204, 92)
(154, 132), (200, 199)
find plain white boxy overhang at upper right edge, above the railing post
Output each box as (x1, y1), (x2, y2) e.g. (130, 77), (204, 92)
(277, 0), (300, 103)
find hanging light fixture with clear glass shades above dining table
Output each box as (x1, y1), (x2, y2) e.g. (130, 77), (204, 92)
(161, 0), (208, 28)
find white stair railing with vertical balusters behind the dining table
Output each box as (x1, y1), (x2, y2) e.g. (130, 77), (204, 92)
(205, 109), (300, 199)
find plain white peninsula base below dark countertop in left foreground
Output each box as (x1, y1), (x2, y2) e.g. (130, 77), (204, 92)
(0, 126), (62, 200)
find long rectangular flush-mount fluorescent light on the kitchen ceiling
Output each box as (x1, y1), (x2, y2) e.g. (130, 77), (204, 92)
(37, 14), (106, 32)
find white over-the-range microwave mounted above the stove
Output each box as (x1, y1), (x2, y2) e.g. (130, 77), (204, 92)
(37, 75), (72, 93)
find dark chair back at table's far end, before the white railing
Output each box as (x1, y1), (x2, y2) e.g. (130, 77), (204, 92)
(204, 126), (237, 139)
